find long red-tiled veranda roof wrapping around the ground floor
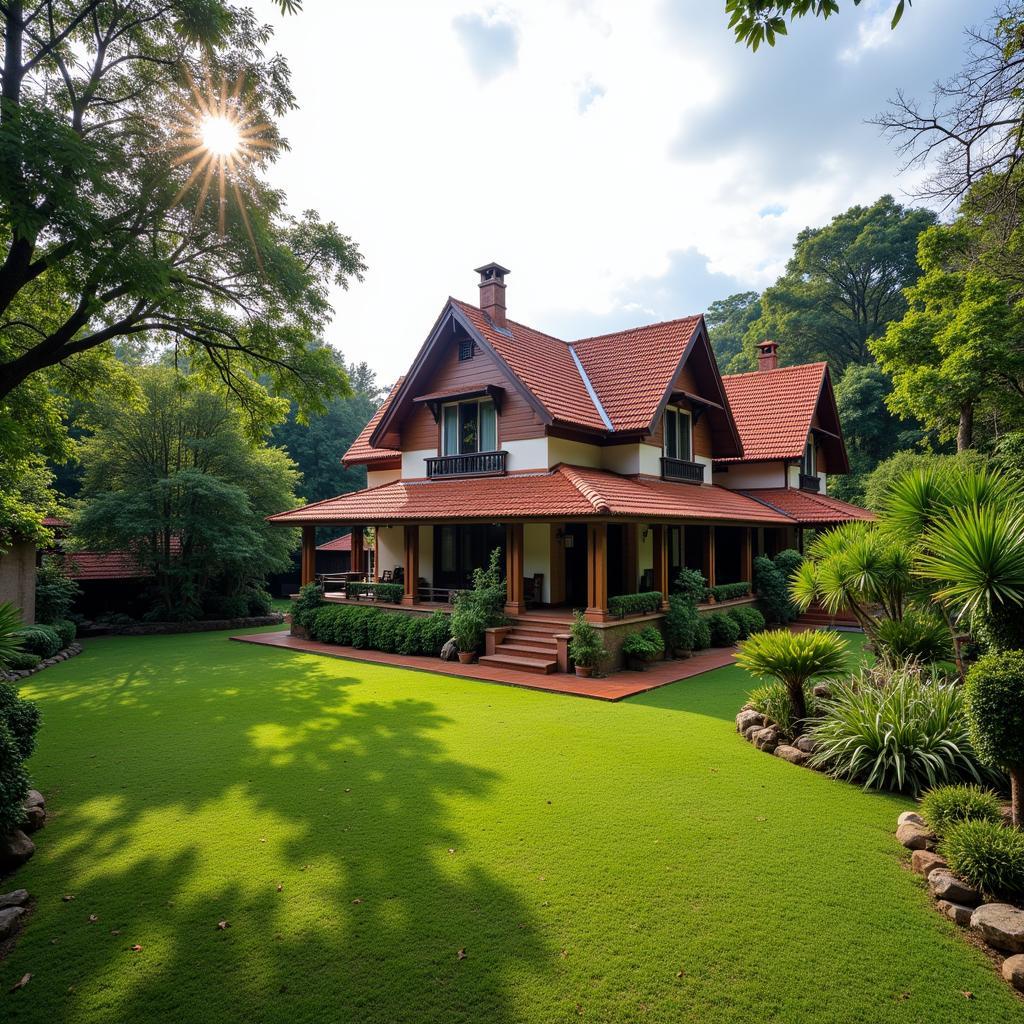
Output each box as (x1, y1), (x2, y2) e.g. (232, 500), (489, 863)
(268, 465), (791, 526)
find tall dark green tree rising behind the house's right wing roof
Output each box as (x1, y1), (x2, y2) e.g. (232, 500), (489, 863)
(744, 196), (935, 375)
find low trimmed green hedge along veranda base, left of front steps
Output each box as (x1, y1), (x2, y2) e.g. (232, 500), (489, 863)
(306, 604), (452, 657)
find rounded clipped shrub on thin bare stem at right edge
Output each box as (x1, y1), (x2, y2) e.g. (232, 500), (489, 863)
(964, 650), (1024, 828)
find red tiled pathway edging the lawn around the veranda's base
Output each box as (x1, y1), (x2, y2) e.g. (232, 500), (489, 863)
(231, 632), (736, 700)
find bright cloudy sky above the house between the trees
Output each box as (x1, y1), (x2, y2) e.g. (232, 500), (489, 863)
(255, 0), (989, 385)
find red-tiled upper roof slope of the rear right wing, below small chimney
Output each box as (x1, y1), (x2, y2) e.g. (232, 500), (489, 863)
(716, 362), (826, 462)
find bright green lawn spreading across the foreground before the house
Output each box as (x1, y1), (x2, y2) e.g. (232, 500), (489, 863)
(0, 634), (1024, 1024)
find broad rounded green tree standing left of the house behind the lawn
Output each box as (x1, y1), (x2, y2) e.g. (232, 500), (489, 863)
(70, 367), (299, 620)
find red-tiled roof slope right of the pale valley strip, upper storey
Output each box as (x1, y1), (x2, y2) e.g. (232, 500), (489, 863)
(572, 316), (700, 431)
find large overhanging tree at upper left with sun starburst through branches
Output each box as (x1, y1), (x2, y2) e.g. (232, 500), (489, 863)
(0, 0), (364, 421)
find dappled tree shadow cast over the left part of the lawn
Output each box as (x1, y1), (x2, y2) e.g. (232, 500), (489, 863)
(4, 645), (551, 1022)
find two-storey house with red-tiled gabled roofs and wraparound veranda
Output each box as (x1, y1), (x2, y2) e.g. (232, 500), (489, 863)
(270, 263), (869, 667)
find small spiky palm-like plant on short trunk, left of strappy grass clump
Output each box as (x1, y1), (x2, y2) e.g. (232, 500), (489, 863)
(736, 630), (847, 735)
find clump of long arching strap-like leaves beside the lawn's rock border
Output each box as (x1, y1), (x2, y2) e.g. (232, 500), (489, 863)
(811, 665), (984, 796)
